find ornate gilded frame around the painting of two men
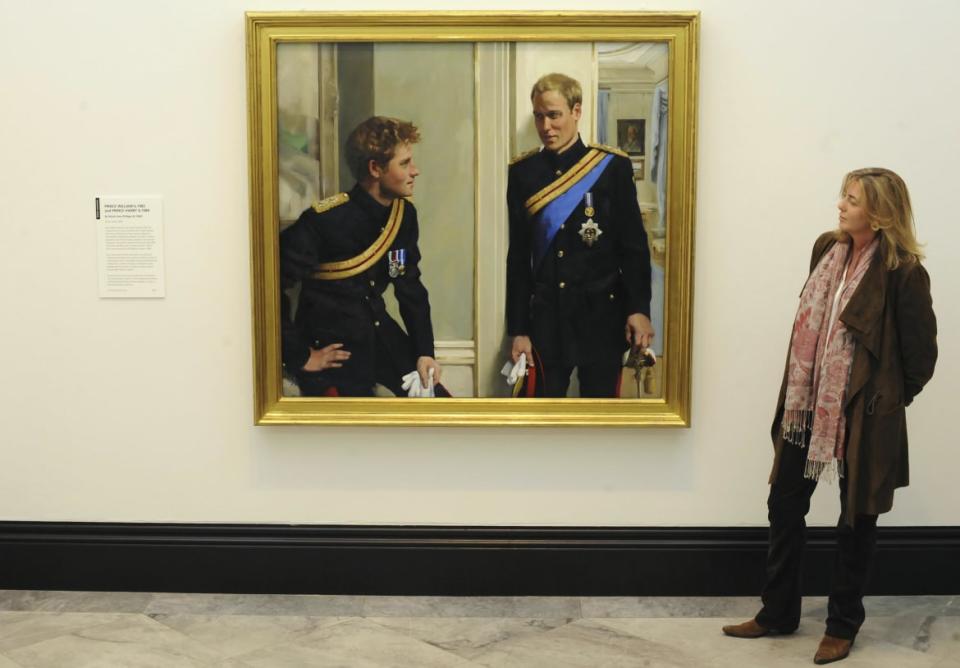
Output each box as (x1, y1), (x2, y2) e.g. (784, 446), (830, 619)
(246, 12), (699, 427)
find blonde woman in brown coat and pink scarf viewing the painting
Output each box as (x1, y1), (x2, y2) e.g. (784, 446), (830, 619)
(723, 169), (937, 664)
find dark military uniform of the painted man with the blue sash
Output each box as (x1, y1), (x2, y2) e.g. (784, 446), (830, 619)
(507, 138), (650, 397)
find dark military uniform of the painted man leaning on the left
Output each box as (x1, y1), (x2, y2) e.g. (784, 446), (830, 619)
(280, 185), (434, 396)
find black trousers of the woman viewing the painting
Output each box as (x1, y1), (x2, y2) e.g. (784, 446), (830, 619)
(756, 443), (877, 640)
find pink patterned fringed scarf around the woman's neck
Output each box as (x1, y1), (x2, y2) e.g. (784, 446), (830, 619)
(782, 239), (877, 480)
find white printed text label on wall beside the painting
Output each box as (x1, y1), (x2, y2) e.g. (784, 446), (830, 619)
(96, 197), (165, 297)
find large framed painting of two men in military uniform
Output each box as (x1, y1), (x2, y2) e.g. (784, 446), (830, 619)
(247, 12), (699, 426)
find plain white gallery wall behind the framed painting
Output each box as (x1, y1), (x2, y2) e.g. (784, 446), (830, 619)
(0, 0), (960, 526)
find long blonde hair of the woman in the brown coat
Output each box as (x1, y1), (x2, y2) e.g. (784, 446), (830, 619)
(837, 167), (923, 271)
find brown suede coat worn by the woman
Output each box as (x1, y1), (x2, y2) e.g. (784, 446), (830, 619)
(770, 232), (937, 525)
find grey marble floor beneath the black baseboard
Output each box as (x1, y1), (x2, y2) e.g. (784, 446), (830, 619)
(0, 590), (960, 668)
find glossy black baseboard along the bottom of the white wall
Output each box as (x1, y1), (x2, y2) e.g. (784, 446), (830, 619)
(0, 522), (960, 596)
